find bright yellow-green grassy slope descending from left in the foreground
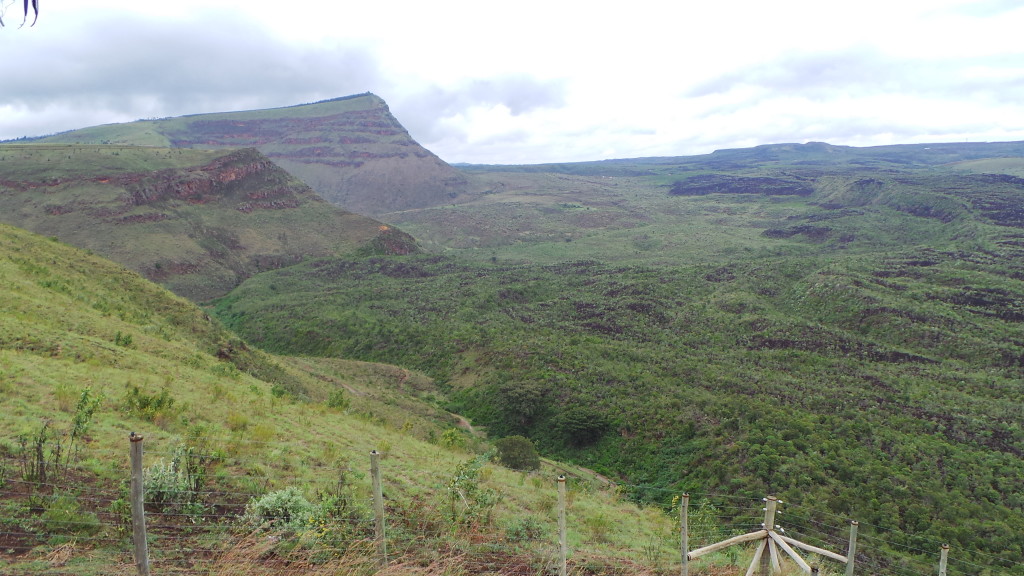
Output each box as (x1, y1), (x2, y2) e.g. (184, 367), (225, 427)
(0, 224), (733, 574)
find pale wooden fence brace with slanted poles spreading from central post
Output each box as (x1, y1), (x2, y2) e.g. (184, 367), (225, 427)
(681, 494), (857, 576)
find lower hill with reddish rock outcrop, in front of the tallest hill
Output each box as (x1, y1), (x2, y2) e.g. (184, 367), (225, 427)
(0, 145), (415, 300)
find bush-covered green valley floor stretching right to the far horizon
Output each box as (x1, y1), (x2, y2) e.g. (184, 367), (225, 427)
(215, 143), (1024, 572)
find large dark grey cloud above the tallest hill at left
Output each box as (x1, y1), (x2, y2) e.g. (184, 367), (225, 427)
(0, 13), (383, 138)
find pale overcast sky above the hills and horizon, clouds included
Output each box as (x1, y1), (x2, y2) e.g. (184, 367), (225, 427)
(0, 0), (1024, 164)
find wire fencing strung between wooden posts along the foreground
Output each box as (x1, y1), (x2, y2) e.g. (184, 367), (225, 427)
(0, 434), (1024, 576)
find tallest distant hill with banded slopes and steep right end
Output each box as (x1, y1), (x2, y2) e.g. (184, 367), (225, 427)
(35, 93), (466, 215)
